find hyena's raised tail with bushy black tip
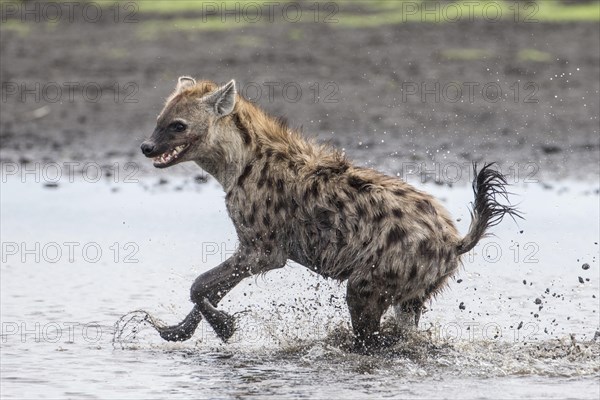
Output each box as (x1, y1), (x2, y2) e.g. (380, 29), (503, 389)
(457, 163), (523, 254)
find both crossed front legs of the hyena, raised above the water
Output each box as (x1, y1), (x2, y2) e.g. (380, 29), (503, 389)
(159, 249), (285, 341)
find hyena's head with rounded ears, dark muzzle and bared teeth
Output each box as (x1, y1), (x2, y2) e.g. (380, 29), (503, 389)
(141, 76), (236, 172)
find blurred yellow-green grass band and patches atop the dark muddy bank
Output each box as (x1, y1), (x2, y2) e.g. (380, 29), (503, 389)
(0, 0), (600, 37)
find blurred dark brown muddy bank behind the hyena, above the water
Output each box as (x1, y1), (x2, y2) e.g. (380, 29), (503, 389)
(0, 2), (600, 180)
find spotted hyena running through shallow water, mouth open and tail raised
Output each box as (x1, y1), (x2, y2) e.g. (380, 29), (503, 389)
(141, 77), (517, 347)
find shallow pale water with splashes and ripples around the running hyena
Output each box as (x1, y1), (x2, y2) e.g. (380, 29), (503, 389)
(0, 178), (600, 399)
